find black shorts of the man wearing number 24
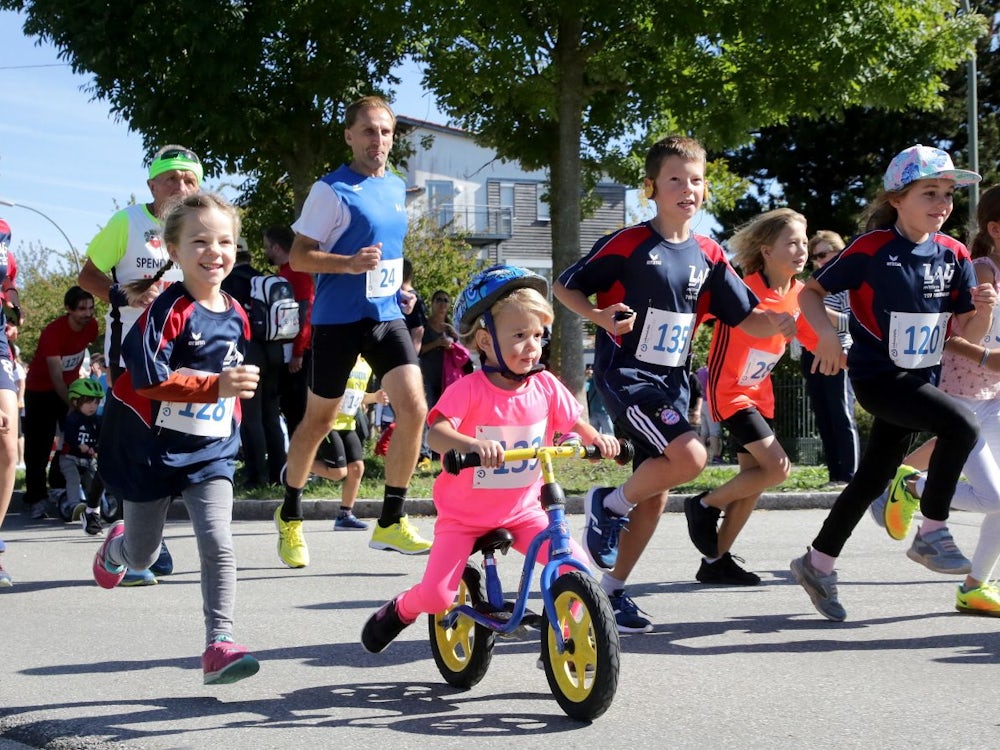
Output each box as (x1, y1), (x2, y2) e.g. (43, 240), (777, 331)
(309, 318), (419, 399)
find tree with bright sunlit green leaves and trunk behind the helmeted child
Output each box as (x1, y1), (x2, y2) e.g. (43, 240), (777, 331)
(410, 0), (983, 394)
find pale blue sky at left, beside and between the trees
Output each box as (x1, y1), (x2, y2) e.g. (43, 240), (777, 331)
(0, 11), (447, 258)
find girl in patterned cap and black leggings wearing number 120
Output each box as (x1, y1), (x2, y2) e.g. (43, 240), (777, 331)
(791, 145), (997, 621)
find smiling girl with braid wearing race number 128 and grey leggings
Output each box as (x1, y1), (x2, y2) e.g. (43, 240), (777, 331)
(93, 193), (259, 684)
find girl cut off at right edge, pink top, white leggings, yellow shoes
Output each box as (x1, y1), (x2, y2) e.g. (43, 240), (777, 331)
(872, 185), (1000, 617)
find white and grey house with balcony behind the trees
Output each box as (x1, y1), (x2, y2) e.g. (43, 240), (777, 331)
(396, 116), (626, 280)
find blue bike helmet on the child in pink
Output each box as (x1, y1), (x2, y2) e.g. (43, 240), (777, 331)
(454, 265), (549, 380)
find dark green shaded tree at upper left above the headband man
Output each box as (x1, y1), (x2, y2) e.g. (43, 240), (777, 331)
(0, 0), (411, 226)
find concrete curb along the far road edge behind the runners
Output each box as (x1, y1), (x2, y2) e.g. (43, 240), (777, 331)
(174, 492), (837, 521)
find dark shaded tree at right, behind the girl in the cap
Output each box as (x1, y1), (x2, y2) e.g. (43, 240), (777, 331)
(716, 0), (1000, 237)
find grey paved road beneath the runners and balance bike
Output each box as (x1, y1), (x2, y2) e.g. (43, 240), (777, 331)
(0, 496), (1000, 750)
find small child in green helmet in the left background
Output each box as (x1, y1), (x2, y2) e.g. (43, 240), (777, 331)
(59, 378), (104, 533)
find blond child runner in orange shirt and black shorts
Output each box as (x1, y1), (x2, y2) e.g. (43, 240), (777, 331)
(684, 208), (816, 586)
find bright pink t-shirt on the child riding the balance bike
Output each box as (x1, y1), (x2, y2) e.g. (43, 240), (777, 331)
(427, 370), (583, 528)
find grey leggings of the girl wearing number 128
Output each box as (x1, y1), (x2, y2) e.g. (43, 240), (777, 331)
(107, 478), (236, 644)
